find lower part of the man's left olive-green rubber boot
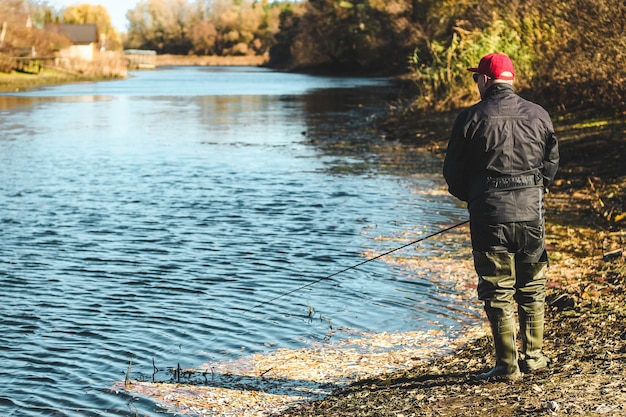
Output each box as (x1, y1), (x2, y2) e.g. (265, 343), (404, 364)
(476, 307), (522, 381)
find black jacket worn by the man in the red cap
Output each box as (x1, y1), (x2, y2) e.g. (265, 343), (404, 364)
(443, 84), (559, 223)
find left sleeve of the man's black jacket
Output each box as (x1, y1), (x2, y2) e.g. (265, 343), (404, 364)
(443, 112), (469, 201)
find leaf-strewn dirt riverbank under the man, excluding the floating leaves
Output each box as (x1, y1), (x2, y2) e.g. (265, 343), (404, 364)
(281, 111), (626, 417)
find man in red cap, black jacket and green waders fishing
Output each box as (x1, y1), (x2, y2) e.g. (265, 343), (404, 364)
(443, 53), (559, 380)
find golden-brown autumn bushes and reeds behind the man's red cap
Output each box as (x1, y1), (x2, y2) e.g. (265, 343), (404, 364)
(404, 0), (626, 109)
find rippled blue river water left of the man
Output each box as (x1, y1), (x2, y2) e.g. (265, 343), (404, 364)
(0, 68), (471, 416)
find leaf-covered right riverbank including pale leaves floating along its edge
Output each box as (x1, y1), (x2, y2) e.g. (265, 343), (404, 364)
(120, 103), (626, 417)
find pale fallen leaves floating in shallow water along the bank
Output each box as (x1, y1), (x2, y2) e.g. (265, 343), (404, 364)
(114, 213), (488, 416)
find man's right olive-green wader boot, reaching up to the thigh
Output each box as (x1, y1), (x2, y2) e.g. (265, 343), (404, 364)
(516, 262), (548, 373)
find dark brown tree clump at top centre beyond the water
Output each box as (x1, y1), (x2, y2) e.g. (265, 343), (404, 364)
(276, 0), (416, 72)
